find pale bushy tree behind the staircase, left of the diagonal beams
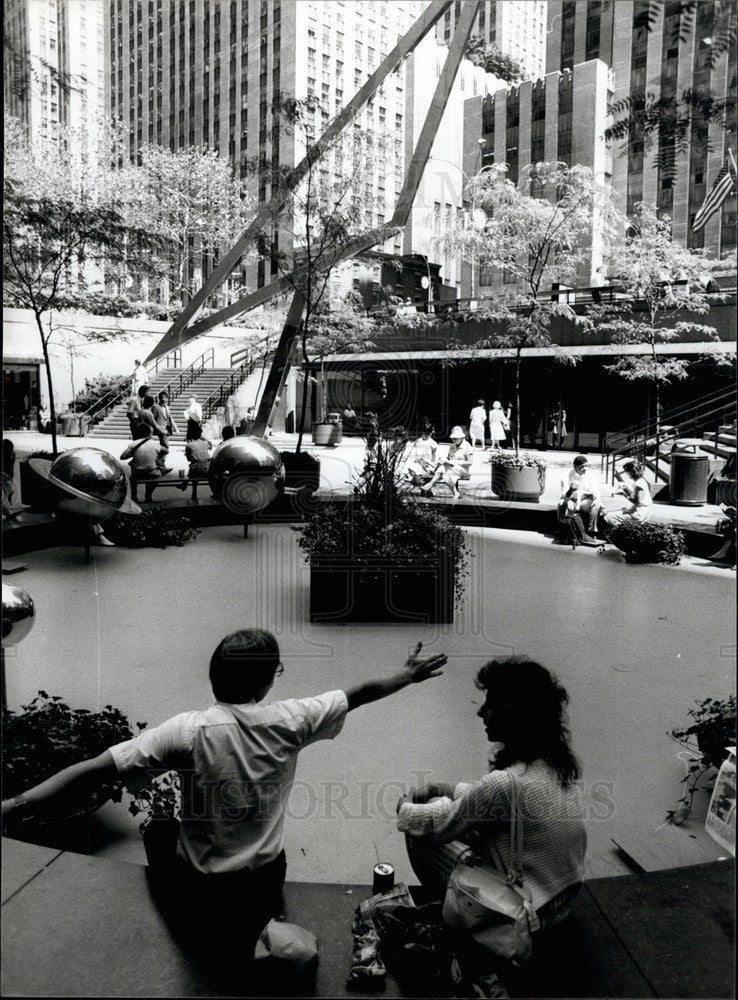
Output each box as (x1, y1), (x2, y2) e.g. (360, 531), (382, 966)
(115, 145), (253, 303)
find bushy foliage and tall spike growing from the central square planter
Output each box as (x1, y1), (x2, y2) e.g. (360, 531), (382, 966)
(298, 428), (469, 602)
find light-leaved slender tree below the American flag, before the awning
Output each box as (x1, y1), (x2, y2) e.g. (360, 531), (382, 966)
(597, 205), (729, 434)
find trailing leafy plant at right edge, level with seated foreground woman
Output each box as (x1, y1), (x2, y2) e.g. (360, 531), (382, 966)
(666, 695), (736, 826)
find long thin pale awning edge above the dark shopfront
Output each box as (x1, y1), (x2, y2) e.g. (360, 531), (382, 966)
(325, 340), (736, 364)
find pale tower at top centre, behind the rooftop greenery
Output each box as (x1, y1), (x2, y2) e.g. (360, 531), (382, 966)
(436, 0), (547, 80)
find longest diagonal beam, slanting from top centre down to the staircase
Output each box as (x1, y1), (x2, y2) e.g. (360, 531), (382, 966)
(146, 0), (454, 363)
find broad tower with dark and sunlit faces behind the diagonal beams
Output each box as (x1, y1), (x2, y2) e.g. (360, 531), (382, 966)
(105, 0), (434, 287)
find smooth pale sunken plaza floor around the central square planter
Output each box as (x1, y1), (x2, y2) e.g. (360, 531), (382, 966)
(7, 512), (736, 883)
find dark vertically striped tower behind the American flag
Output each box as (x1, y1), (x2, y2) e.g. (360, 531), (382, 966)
(546, 0), (736, 256)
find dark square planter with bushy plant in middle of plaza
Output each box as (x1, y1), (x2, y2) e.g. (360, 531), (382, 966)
(298, 433), (468, 624)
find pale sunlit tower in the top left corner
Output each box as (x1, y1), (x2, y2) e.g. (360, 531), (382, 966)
(4, 0), (105, 140)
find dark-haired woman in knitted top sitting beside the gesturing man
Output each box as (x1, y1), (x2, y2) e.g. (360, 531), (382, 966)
(397, 657), (586, 944)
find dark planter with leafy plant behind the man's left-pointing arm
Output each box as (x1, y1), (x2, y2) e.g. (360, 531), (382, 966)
(2, 691), (141, 853)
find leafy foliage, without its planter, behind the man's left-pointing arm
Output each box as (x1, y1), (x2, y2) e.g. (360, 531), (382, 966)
(2, 691), (146, 814)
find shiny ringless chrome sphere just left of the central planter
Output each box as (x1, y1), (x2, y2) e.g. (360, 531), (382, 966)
(208, 435), (284, 514)
